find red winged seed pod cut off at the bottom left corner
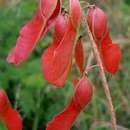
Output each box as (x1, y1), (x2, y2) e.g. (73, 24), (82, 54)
(0, 90), (22, 130)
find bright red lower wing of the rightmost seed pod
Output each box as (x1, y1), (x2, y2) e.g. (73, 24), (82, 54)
(100, 33), (121, 74)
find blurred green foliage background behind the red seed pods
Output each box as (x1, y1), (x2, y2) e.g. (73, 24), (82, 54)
(0, 0), (130, 130)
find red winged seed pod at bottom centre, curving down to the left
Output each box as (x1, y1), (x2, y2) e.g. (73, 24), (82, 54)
(46, 77), (93, 130)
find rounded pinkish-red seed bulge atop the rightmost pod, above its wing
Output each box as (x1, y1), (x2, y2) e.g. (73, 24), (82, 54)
(87, 7), (108, 43)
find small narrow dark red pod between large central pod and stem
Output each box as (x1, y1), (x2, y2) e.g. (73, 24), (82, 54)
(75, 38), (84, 74)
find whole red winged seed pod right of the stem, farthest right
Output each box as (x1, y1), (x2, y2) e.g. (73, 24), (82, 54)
(87, 6), (120, 74)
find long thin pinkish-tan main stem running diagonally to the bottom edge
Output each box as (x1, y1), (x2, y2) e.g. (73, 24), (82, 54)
(86, 22), (117, 130)
